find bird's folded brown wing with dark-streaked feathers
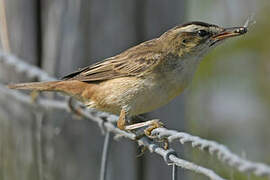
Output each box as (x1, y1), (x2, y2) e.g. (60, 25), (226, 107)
(63, 40), (161, 82)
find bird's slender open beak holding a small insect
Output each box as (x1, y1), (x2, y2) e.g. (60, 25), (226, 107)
(212, 27), (247, 41)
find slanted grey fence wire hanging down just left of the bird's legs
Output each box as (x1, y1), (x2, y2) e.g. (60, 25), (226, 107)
(99, 132), (111, 180)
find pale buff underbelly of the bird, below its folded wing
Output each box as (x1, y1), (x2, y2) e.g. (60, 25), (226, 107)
(85, 78), (185, 116)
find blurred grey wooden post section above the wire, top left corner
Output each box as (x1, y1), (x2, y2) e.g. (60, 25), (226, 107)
(1, 0), (39, 65)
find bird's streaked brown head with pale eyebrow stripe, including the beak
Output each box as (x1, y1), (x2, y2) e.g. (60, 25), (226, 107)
(159, 22), (247, 56)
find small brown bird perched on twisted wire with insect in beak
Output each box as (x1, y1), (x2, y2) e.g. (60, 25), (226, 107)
(9, 22), (247, 133)
